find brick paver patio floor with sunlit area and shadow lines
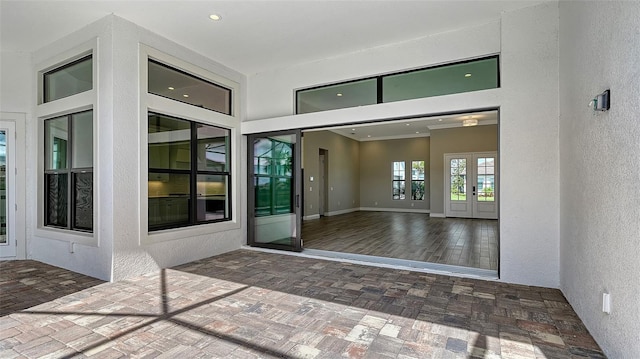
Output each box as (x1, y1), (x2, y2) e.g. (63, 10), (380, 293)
(0, 250), (604, 358)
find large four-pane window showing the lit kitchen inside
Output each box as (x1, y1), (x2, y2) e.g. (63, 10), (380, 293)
(148, 113), (231, 230)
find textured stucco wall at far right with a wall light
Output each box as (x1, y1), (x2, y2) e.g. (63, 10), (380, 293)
(560, 1), (640, 358)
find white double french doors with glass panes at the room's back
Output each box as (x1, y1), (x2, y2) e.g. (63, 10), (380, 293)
(444, 152), (499, 219)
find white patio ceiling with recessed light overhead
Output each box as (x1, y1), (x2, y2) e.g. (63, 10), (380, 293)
(0, 0), (542, 75)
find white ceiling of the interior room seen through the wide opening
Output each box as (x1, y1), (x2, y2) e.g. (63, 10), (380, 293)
(306, 111), (498, 141)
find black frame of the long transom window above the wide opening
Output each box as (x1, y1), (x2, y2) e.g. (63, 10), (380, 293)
(295, 54), (501, 115)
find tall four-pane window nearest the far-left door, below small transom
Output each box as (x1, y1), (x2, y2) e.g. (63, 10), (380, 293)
(44, 111), (93, 232)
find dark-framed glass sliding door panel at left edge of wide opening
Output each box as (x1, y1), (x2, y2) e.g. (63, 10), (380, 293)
(247, 130), (302, 251)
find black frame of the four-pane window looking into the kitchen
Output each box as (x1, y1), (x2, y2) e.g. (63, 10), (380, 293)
(147, 111), (233, 232)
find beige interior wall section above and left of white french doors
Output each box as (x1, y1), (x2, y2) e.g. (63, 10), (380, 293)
(429, 125), (498, 216)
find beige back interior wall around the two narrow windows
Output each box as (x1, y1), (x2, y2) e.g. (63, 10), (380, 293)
(360, 137), (430, 212)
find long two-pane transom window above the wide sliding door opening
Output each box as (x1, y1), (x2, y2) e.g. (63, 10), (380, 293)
(296, 56), (500, 114)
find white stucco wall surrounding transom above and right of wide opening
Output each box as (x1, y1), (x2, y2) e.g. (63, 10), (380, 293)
(242, 3), (559, 288)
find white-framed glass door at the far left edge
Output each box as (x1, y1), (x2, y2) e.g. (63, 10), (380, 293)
(0, 121), (17, 257)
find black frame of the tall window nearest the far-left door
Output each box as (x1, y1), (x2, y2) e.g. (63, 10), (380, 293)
(43, 109), (95, 233)
